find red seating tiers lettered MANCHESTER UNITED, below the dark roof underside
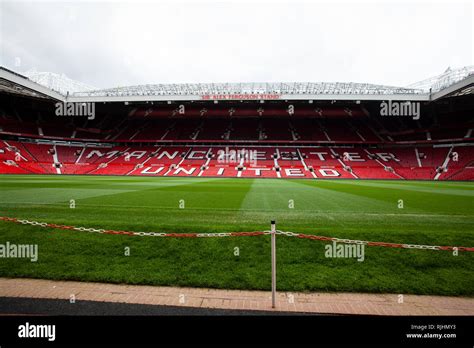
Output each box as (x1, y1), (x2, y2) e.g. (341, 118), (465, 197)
(0, 102), (474, 180)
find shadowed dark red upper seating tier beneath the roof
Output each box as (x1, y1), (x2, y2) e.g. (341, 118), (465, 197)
(0, 104), (474, 145)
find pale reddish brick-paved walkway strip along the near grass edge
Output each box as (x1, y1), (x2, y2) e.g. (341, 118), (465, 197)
(0, 278), (474, 315)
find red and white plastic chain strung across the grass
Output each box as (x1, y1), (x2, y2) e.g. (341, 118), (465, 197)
(0, 216), (474, 252)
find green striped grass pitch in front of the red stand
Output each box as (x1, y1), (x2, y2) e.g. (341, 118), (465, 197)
(0, 175), (474, 296)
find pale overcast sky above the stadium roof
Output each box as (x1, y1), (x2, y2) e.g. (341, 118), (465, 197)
(0, 0), (474, 88)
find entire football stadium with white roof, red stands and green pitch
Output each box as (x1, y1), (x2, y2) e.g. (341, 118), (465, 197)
(0, 62), (474, 296)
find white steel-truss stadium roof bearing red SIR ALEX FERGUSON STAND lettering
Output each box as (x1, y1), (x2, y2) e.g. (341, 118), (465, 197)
(0, 66), (474, 102)
